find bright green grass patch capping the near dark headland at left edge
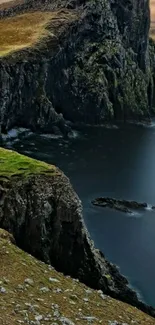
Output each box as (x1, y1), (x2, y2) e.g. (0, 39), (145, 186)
(0, 148), (58, 179)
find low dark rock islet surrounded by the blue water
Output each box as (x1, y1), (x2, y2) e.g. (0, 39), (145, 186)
(92, 197), (147, 213)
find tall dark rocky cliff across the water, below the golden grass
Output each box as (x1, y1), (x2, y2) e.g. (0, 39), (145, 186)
(0, 0), (154, 132)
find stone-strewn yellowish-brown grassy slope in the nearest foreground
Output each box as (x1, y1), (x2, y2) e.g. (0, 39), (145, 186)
(0, 230), (155, 325)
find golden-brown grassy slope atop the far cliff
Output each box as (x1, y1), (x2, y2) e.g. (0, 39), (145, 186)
(0, 11), (74, 57)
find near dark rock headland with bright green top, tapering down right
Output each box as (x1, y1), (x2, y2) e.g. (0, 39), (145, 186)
(0, 148), (155, 316)
